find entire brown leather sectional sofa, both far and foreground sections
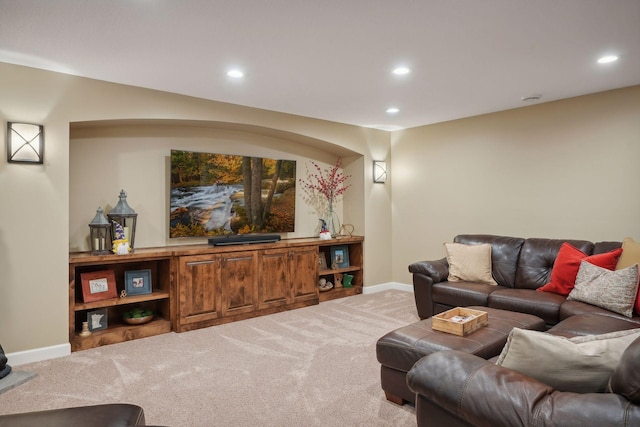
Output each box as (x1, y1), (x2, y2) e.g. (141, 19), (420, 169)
(407, 235), (640, 427)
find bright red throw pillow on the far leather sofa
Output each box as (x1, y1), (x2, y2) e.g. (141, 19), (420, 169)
(538, 242), (622, 296)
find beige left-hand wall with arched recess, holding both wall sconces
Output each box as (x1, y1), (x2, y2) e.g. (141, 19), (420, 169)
(0, 63), (391, 353)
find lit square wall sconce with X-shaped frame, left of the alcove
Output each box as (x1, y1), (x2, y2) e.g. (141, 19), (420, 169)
(7, 122), (44, 165)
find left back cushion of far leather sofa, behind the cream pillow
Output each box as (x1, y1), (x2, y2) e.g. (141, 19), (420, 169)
(453, 234), (525, 288)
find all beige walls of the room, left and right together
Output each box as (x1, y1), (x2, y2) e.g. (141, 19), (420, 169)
(0, 57), (640, 353)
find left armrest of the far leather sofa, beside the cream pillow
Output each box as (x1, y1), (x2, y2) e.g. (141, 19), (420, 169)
(409, 258), (449, 319)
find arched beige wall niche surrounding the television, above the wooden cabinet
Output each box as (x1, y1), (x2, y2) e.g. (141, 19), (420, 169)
(69, 119), (365, 252)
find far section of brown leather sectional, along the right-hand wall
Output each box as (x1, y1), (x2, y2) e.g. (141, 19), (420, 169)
(409, 234), (640, 328)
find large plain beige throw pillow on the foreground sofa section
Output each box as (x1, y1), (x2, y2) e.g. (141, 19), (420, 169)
(496, 328), (640, 393)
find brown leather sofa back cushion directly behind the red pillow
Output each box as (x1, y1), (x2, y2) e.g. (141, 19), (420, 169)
(515, 238), (594, 289)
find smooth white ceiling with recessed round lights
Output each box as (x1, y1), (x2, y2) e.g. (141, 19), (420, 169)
(0, 0), (640, 130)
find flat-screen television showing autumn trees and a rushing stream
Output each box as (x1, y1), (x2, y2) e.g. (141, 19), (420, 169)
(169, 150), (296, 238)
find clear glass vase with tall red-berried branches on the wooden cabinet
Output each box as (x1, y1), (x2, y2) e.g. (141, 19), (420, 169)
(300, 157), (351, 237)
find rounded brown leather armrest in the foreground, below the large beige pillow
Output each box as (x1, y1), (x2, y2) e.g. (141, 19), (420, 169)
(407, 350), (640, 427)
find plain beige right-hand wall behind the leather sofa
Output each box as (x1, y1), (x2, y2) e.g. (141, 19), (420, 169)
(391, 86), (640, 283)
